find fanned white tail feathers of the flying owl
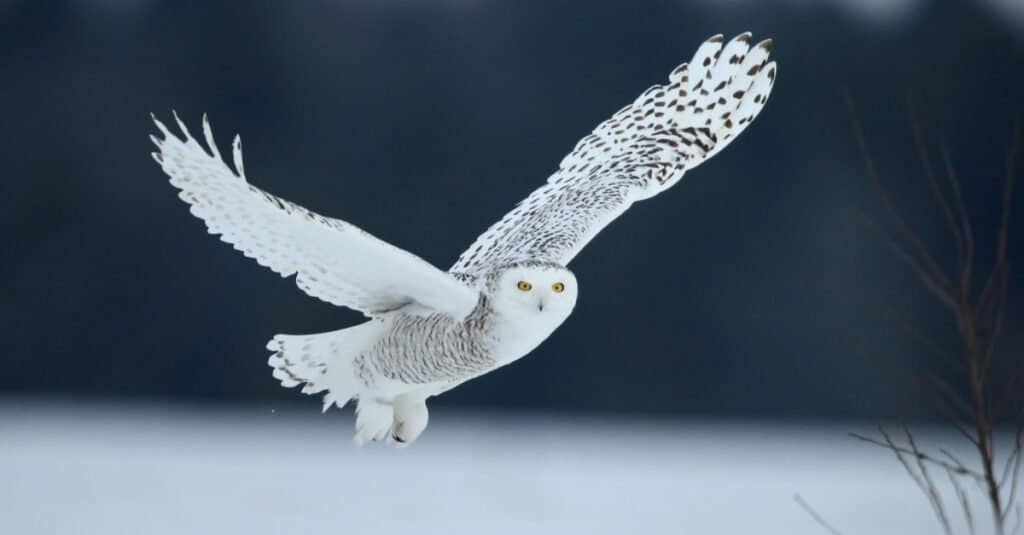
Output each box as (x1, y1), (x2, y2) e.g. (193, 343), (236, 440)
(266, 324), (378, 412)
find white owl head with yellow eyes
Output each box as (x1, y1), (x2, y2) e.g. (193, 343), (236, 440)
(488, 262), (579, 317)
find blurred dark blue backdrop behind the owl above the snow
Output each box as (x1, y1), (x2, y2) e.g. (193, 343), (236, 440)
(0, 0), (1024, 418)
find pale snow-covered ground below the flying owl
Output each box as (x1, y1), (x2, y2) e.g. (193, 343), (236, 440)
(0, 400), (1003, 535)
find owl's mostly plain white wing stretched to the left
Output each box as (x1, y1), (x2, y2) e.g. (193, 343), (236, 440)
(151, 115), (478, 318)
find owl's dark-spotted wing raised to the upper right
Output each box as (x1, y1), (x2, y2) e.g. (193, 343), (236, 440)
(451, 33), (775, 274)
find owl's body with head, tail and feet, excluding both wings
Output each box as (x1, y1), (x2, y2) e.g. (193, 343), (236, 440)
(267, 263), (577, 444)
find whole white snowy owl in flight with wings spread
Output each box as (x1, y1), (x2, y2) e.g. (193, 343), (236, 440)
(152, 33), (775, 445)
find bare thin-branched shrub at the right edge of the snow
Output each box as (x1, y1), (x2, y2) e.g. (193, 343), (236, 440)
(845, 91), (1024, 535)
